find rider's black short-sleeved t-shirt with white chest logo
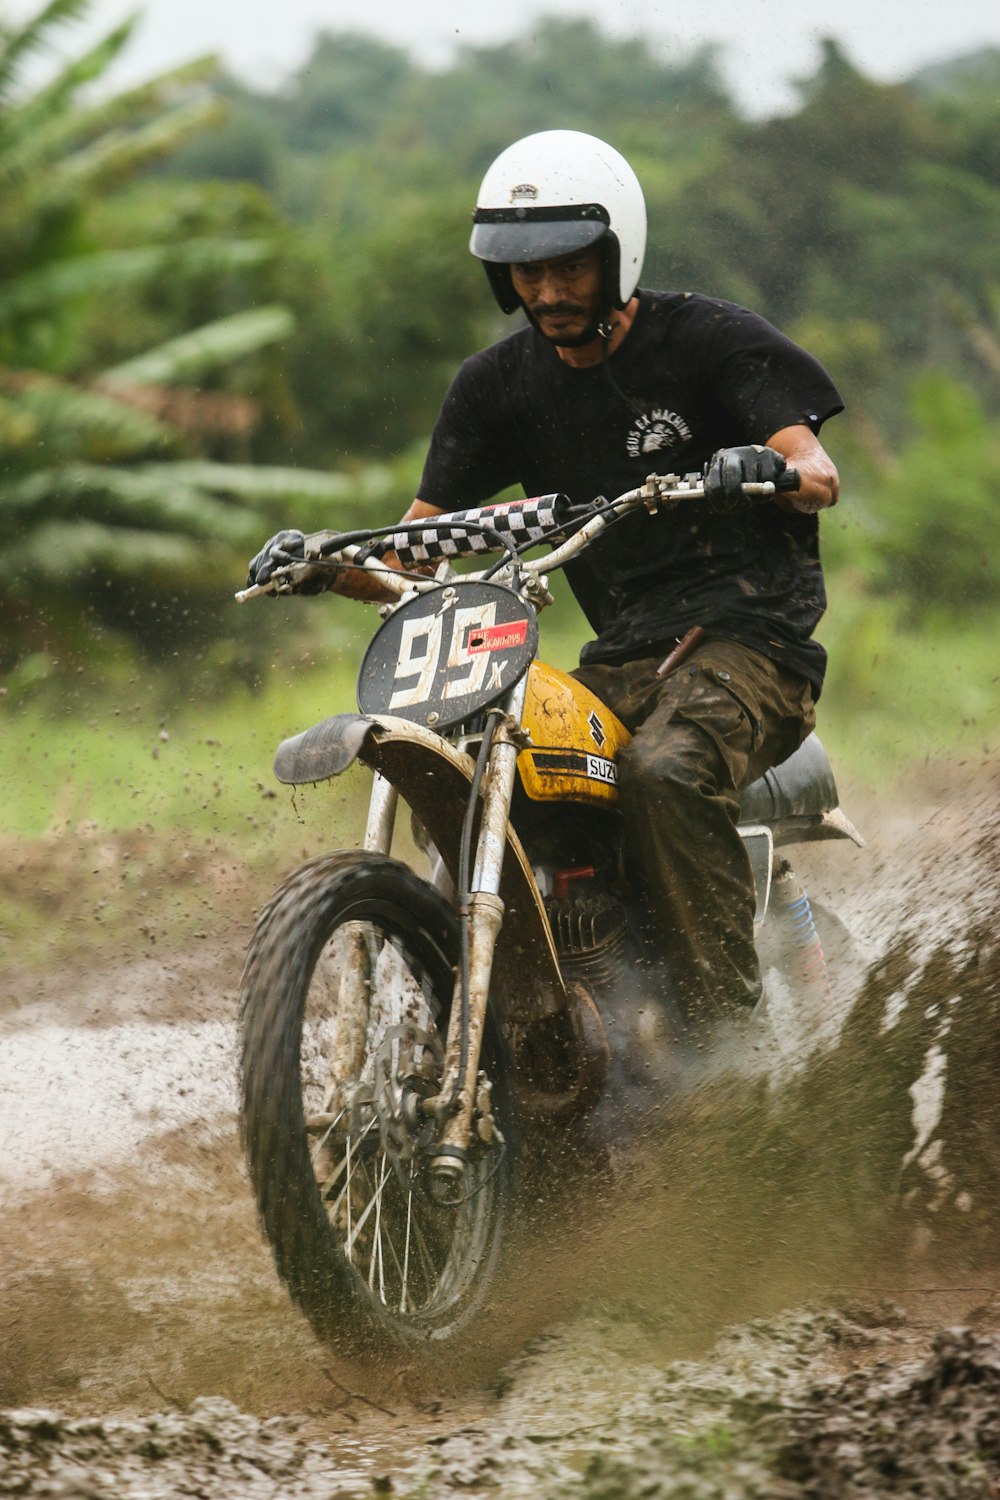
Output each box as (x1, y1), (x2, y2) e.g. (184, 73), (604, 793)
(418, 291), (843, 692)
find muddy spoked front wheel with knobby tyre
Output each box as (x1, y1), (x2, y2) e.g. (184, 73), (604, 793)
(241, 854), (516, 1347)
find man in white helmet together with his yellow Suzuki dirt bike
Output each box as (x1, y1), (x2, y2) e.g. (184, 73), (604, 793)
(243, 131), (856, 1343)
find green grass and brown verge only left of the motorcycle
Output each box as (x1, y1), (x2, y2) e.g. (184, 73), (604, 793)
(0, 621), (370, 972)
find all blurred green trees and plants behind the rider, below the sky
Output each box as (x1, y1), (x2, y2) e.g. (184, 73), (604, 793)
(0, 0), (1000, 786)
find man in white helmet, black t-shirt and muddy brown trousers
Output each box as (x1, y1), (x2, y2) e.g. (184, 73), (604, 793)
(249, 131), (843, 1020)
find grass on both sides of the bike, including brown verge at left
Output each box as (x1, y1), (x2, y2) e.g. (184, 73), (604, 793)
(0, 581), (1000, 972)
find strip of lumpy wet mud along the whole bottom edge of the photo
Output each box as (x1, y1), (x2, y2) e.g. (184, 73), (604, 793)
(0, 1305), (1000, 1500)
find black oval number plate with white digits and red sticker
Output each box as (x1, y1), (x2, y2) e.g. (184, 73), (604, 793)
(358, 581), (538, 729)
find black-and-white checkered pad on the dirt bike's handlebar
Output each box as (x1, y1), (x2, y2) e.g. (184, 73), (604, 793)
(364, 495), (571, 566)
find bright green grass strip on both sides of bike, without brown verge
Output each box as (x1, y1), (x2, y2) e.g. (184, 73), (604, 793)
(0, 591), (1000, 843)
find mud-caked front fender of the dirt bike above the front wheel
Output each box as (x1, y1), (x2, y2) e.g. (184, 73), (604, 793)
(274, 714), (567, 1022)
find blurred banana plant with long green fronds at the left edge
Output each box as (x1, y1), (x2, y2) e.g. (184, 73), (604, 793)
(0, 0), (407, 671)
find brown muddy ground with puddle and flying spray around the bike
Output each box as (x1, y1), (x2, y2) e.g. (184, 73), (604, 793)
(0, 767), (1000, 1500)
